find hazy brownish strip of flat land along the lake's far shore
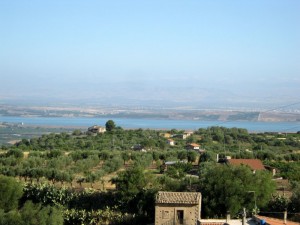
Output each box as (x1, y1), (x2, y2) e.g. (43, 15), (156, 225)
(0, 105), (300, 122)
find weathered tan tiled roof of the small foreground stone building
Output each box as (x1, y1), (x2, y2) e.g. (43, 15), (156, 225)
(156, 191), (201, 204)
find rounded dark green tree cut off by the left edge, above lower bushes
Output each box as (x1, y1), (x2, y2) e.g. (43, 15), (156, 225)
(0, 176), (23, 212)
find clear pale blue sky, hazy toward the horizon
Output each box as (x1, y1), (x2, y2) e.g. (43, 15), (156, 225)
(0, 0), (300, 108)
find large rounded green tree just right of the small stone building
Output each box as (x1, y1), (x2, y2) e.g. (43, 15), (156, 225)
(200, 165), (275, 217)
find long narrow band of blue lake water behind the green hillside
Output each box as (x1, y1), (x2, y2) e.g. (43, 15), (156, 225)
(0, 116), (300, 132)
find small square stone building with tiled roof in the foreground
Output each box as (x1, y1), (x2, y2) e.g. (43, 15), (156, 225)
(155, 191), (201, 225)
